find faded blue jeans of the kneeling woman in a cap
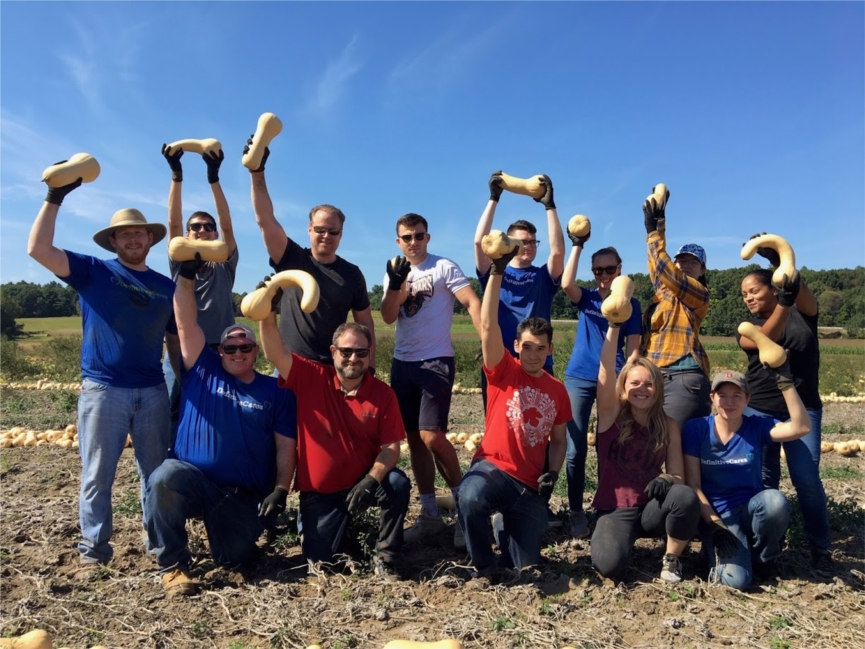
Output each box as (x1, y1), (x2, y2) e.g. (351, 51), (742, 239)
(700, 489), (790, 590)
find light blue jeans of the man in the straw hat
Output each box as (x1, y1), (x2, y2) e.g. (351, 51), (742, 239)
(78, 379), (169, 563)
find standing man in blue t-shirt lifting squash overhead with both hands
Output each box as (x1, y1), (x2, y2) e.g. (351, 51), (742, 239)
(475, 171), (565, 410)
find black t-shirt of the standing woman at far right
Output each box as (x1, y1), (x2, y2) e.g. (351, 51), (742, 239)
(736, 307), (823, 421)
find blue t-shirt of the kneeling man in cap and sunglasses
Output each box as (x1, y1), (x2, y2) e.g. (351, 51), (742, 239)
(172, 347), (297, 496)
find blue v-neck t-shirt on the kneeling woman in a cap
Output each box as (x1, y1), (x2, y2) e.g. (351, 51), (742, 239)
(682, 415), (778, 515)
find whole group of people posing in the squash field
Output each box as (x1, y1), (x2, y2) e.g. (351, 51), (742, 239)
(28, 147), (831, 595)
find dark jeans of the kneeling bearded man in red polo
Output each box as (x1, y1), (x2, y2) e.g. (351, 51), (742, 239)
(300, 469), (411, 563)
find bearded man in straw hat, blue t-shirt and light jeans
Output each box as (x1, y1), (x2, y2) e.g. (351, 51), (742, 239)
(27, 178), (179, 574)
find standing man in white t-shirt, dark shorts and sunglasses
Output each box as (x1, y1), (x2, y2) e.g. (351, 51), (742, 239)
(381, 214), (481, 548)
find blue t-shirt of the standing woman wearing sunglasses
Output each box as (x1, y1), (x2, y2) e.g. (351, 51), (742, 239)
(565, 288), (643, 381)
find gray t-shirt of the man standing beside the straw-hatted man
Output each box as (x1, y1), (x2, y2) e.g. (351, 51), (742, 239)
(168, 246), (238, 345)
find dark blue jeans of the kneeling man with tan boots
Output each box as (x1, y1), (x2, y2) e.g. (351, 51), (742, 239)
(147, 459), (264, 572)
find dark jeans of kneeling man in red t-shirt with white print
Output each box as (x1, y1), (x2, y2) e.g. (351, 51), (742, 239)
(457, 460), (547, 569)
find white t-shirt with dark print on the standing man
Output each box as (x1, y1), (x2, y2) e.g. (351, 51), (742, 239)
(384, 254), (470, 361)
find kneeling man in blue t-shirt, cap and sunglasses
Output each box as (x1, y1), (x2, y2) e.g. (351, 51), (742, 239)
(145, 255), (297, 595)
